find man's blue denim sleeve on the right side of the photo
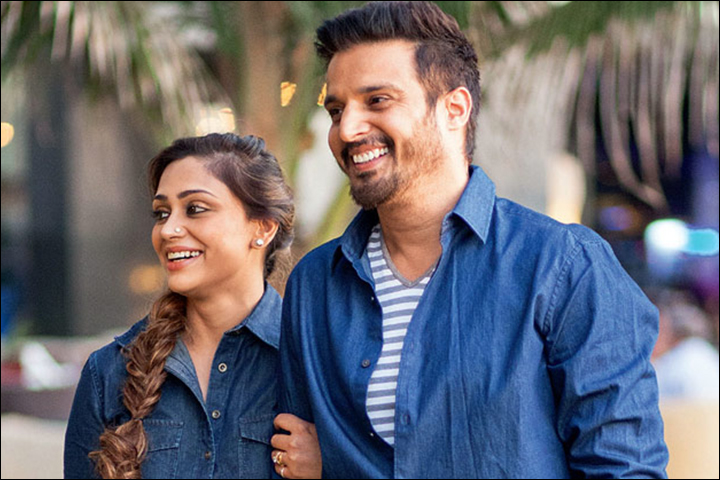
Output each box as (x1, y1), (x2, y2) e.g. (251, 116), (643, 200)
(545, 240), (668, 478)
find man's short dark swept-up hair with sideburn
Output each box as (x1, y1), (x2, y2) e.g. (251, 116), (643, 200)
(315, 2), (480, 161)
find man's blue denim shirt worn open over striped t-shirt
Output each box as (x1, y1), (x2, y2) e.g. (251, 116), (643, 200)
(280, 167), (668, 478)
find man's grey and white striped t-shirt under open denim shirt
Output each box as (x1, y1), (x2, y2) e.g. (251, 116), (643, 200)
(367, 225), (435, 445)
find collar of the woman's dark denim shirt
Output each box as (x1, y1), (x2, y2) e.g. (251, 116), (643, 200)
(115, 283), (282, 349)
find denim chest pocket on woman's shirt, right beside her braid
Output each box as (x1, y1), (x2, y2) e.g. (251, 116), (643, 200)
(141, 419), (183, 478)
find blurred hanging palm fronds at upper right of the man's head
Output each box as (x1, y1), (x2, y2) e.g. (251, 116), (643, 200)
(471, 2), (718, 213)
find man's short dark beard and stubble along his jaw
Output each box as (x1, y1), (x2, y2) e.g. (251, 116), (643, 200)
(350, 120), (442, 210)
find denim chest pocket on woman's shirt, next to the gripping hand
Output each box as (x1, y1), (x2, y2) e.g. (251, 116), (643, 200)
(238, 413), (275, 478)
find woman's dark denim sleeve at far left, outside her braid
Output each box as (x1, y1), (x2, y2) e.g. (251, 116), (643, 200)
(64, 354), (105, 478)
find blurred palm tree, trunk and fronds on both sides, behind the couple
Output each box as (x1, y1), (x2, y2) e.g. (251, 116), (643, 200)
(2, 1), (718, 238)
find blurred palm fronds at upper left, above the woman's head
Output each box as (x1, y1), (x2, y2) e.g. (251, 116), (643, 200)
(2, 1), (229, 137)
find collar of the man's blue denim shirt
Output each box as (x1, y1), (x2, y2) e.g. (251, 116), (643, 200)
(333, 165), (495, 265)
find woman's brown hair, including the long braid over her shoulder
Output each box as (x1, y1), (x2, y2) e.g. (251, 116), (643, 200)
(90, 133), (295, 478)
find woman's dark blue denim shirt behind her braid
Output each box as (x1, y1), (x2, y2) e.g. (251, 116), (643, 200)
(65, 286), (281, 478)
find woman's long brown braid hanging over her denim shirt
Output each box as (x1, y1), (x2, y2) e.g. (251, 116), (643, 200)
(90, 292), (186, 478)
